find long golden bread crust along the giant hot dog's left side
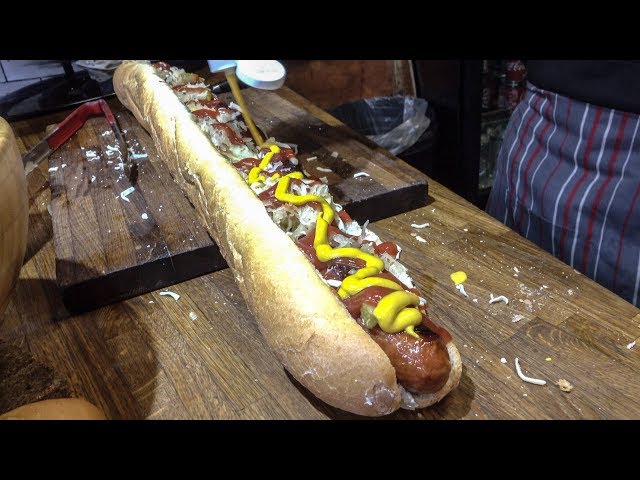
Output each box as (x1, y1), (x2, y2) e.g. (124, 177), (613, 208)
(113, 62), (459, 416)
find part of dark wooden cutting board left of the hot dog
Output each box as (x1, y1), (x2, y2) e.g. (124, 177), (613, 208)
(49, 108), (226, 313)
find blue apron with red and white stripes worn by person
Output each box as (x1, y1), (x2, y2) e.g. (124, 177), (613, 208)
(486, 83), (640, 306)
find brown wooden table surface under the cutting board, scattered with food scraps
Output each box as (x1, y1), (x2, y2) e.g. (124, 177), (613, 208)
(0, 89), (640, 419)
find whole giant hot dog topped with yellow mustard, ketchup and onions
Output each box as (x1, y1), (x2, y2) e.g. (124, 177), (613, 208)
(114, 62), (462, 416)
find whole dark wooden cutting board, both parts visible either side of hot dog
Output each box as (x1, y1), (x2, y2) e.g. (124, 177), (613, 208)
(49, 88), (427, 313)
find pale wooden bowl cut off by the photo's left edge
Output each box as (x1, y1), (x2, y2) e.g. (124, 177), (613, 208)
(0, 117), (29, 320)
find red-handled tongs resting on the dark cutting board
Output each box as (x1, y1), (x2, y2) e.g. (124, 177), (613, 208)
(22, 100), (132, 181)
